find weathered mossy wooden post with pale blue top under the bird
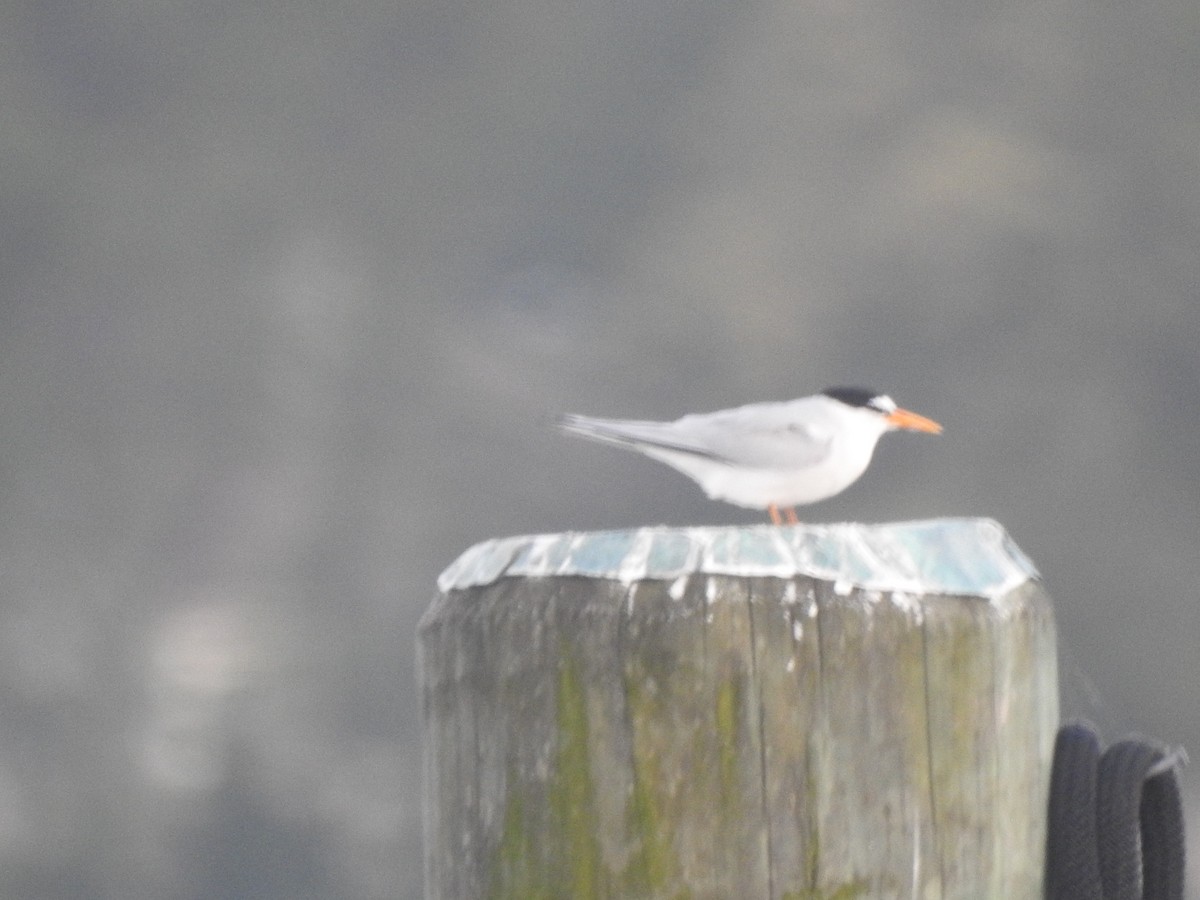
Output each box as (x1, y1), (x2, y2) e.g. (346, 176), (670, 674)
(419, 520), (1058, 900)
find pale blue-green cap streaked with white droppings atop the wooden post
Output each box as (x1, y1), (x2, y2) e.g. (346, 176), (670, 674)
(438, 518), (1038, 598)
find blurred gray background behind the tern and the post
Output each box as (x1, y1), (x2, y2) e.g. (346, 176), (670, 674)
(0, 0), (1200, 900)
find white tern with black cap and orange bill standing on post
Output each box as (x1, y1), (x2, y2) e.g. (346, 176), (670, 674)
(559, 388), (942, 524)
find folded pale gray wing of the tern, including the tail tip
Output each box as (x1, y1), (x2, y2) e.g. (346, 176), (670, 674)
(560, 400), (833, 469)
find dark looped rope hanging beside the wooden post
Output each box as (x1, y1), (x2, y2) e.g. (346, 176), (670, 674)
(1045, 722), (1187, 900)
